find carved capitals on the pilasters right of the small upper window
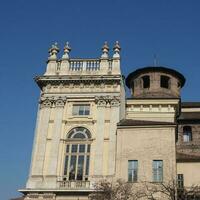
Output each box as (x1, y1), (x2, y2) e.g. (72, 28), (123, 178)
(95, 95), (120, 106)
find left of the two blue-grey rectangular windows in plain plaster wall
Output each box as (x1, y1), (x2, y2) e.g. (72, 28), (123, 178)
(128, 160), (138, 182)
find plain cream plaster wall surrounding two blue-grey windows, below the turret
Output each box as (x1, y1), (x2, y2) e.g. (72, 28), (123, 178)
(116, 127), (176, 182)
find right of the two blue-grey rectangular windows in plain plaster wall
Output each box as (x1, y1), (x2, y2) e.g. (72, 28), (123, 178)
(153, 160), (163, 182)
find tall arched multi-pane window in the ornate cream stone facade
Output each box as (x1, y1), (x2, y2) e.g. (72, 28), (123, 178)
(64, 127), (91, 181)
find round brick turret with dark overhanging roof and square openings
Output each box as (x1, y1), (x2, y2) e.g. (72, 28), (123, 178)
(126, 66), (185, 98)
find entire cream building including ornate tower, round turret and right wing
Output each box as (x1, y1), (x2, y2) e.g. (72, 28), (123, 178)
(20, 42), (200, 200)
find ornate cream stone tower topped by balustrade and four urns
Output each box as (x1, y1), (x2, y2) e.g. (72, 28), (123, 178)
(21, 42), (125, 199)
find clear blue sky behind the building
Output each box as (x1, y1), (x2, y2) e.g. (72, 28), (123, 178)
(0, 0), (200, 200)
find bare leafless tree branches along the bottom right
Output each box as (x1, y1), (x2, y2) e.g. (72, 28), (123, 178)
(89, 180), (200, 200)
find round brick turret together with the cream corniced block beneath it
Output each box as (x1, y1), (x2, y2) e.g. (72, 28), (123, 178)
(126, 66), (185, 122)
